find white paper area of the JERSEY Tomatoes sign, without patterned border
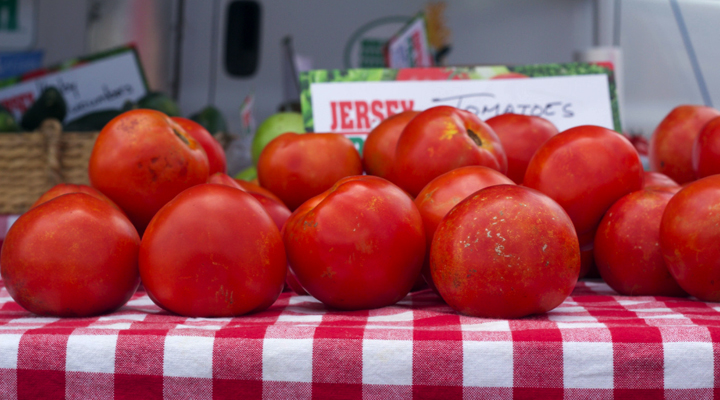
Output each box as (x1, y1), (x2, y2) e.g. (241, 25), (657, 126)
(310, 74), (614, 144)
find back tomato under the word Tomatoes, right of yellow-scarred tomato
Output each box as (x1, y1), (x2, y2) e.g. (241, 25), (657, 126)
(485, 114), (558, 184)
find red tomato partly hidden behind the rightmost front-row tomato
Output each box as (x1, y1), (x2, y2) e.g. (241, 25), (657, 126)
(594, 190), (687, 296)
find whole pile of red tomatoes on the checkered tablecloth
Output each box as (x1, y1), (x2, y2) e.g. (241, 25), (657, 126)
(0, 106), (720, 318)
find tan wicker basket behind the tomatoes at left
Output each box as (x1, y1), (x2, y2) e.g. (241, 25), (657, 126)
(0, 119), (98, 214)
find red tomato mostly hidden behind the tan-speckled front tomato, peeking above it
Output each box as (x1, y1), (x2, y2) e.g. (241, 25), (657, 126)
(415, 165), (513, 292)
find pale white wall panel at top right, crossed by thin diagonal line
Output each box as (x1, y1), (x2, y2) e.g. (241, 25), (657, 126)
(620, 0), (720, 136)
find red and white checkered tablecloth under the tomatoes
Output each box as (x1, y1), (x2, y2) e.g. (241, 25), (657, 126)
(0, 282), (720, 399)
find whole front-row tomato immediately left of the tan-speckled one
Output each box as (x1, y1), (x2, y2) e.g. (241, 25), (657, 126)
(284, 176), (425, 310)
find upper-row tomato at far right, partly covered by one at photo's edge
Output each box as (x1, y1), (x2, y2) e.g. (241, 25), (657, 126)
(648, 105), (720, 184)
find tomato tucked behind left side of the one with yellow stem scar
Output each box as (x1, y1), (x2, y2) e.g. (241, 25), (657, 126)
(362, 111), (420, 181)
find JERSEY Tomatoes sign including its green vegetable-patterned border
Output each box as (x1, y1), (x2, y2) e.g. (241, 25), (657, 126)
(301, 63), (620, 151)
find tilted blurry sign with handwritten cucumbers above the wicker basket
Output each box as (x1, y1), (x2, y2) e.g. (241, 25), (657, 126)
(0, 48), (147, 121)
